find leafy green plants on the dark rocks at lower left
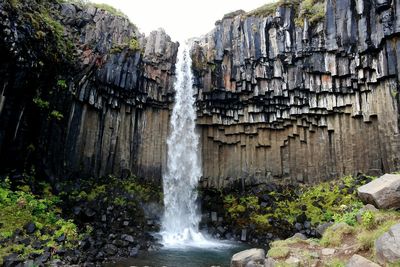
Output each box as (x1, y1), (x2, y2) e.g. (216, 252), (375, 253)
(0, 182), (78, 265)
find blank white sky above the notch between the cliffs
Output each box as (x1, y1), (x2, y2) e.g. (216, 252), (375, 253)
(92, 0), (273, 41)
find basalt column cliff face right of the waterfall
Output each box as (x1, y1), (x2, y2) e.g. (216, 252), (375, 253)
(192, 0), (400, 187)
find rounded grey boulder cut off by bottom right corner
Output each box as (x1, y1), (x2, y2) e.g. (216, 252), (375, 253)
(375, 223), (400, 264)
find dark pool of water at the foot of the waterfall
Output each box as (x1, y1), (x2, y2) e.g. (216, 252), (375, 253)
(105, 242), (249, 267)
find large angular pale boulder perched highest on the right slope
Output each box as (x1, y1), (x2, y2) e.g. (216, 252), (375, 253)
(358, 174), (400, 209)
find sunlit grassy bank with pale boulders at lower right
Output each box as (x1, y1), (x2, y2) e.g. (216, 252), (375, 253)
(231, 174), (400, 267)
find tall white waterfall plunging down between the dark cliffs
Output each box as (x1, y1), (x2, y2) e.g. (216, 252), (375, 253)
(161, 43), (220, 247)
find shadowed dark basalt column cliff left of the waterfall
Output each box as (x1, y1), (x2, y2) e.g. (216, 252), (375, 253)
(0, 1), (178, 182)
